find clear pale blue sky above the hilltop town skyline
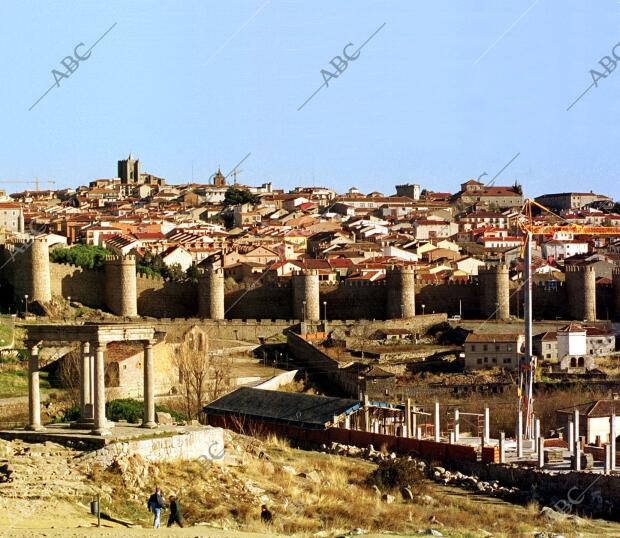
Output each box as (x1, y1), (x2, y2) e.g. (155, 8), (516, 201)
(0, 0), (620, 199)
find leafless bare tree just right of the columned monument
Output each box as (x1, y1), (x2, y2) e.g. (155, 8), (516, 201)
(171, 330), (232, 418)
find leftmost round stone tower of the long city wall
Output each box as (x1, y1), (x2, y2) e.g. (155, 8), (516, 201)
(12, 238), (52, 303)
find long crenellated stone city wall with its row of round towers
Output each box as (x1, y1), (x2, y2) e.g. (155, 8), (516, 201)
(0, 240), (620, 321)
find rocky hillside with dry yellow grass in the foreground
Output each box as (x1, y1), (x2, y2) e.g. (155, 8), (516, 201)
(0, 433), (620, 538)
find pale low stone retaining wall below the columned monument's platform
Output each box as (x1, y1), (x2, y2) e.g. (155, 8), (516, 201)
(86, 427), (224, 468)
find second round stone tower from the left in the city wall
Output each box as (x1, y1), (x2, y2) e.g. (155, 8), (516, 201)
(104, 256), (138, 317)
